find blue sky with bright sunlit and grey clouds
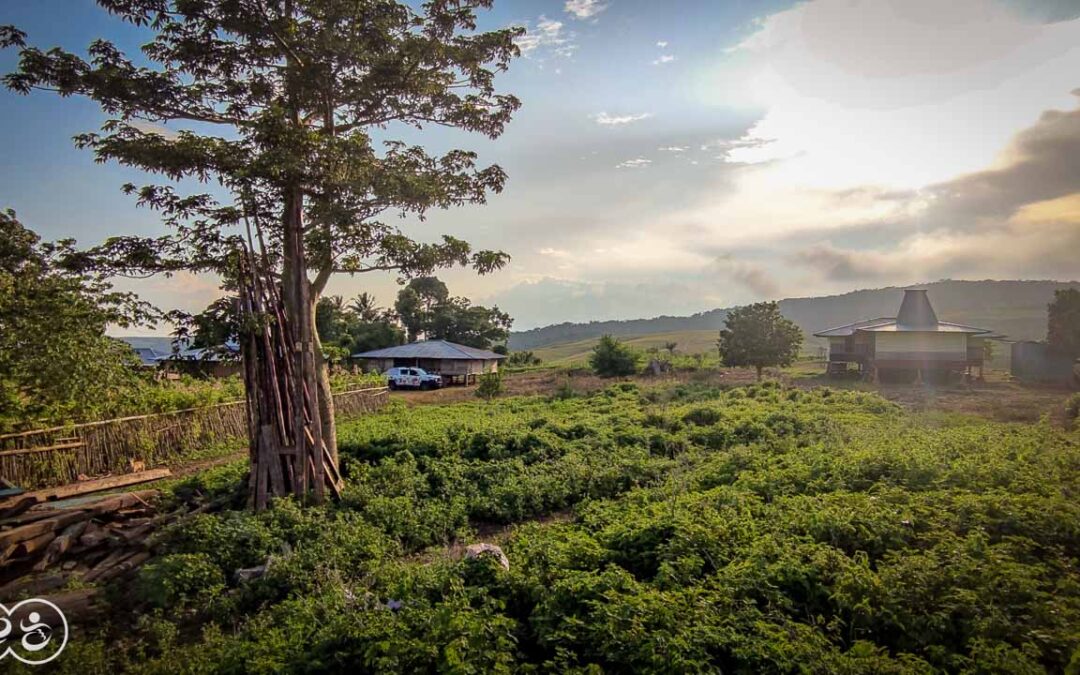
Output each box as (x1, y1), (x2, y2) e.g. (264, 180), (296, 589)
(0, 0), (1080, 332)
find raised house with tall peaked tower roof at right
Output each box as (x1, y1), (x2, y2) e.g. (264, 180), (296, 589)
(814, 289), (1001, 381)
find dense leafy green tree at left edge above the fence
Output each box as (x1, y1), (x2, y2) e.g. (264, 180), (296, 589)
(0, 211), (152, 430)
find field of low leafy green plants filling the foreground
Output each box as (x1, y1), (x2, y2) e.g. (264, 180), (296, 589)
(46, 382), (1080, 673)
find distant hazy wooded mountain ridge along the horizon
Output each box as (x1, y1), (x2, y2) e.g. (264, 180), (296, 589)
(509, 280), (1080, 350)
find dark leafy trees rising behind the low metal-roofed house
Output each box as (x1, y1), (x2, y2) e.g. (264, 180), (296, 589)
(394, 276), (513, 349)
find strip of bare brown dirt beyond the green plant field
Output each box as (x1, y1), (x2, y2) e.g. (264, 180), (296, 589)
(391, 368), (1072, 422)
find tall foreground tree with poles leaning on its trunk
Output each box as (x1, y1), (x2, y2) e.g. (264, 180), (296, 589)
(0, 0), (523, 494)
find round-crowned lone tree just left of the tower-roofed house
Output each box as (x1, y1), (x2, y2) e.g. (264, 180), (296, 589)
(717, 302), (802, 381)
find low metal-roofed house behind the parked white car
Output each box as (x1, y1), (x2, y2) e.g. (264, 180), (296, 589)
(353, 340), (505, 384)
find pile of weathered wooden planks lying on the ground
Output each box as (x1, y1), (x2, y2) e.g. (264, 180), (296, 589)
(0, 469), (217, 602)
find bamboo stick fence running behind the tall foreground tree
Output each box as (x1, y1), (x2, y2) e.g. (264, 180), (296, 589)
(0, 387), (388, 489)
